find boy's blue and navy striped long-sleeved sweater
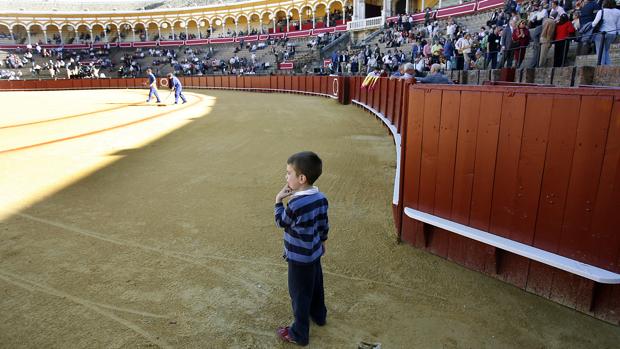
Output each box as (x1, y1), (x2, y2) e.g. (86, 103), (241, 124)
(275, 188), (329, 264)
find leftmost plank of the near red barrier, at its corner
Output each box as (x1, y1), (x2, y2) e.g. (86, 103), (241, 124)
(401, 89), (425, 245)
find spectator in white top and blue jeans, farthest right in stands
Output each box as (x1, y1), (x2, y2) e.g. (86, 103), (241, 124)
(592, 0), (620, 65)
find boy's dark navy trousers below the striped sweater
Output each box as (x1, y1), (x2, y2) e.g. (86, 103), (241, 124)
(288, 258), (327, 344)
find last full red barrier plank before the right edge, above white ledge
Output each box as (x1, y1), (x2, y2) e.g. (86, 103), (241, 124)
(559, 96), (617, 264)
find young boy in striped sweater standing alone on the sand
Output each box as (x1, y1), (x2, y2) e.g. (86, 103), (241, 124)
(275, 151), (329, 346)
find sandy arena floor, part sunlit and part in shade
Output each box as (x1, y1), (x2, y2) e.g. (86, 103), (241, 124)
(0, 90), (620, 349)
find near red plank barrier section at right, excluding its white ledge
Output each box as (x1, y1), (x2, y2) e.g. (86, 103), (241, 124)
(402, 86), (620, 323)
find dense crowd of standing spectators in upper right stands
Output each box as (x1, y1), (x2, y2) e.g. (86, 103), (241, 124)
(346, 0), (620, 78)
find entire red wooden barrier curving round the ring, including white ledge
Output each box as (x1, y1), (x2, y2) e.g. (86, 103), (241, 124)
(0, 75), (620, 325)
